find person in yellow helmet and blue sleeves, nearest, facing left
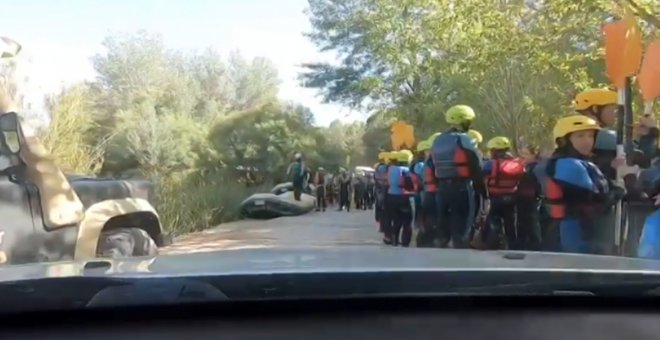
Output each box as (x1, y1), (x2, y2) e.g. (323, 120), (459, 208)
(534, 115), (623, 254)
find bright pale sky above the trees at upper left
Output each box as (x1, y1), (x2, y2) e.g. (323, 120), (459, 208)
(0, 0), (365, 125)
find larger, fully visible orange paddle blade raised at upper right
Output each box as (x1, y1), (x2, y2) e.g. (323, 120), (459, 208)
(603, 15), (642, 89)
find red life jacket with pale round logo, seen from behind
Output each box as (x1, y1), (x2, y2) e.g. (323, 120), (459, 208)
(486, 158), (525, 195)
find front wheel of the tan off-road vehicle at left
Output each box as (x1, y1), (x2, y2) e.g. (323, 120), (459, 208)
(96, 227), (158, 258)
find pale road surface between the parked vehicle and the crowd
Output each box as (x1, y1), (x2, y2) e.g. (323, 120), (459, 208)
(159, 210), (383, 254)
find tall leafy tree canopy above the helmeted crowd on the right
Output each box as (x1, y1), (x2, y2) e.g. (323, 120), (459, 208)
(301, 0), (660, 149)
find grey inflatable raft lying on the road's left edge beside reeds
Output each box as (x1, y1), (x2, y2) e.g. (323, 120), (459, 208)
(241, 188), (316, 219)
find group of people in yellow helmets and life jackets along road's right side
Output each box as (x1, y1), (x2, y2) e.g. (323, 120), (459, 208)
(375, 89), (660, 254)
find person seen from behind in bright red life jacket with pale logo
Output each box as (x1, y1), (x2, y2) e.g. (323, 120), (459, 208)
(484, 136), (525, 249)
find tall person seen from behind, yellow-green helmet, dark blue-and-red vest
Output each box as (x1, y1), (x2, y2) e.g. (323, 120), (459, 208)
(426, 105), (490, 248)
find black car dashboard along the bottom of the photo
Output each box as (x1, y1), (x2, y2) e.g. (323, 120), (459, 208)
(0, 296), (660, 340)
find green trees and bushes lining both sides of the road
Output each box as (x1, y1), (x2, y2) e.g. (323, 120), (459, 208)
(6, 0), (660, 233)
